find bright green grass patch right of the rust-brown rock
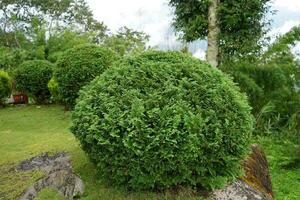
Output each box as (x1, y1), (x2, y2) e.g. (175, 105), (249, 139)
(255, 137), (300, 200)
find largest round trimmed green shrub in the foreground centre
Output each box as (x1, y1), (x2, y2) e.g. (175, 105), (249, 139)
(71, 52), (253, 189)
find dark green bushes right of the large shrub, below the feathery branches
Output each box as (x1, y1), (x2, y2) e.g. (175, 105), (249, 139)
(225, 62), (300, 134)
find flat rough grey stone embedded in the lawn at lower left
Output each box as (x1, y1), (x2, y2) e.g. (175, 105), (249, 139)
(17, 153), (84, 200)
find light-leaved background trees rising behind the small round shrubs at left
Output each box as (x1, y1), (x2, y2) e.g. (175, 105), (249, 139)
(0, 0), (107, 70)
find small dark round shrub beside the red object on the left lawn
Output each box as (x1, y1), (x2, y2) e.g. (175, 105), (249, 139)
(14, 60), (53, 104)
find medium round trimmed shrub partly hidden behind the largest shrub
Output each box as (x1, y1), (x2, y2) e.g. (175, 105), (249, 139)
(54, 45), (116, 109)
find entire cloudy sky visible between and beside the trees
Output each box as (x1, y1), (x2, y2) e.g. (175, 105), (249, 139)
(87, 0), (300, 58)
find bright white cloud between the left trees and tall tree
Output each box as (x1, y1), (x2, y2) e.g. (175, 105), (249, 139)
(87, 0), (172, 46)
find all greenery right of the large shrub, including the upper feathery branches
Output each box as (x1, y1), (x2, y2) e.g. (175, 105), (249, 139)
(224, 27), (300, 135)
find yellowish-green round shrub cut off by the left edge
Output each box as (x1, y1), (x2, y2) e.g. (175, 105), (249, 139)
(0, 70), (12, 105)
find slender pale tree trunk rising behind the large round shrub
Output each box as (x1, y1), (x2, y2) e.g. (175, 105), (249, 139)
(206, 0), (220, 67)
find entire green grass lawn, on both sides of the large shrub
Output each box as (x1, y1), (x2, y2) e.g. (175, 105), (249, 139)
(0, 106), (300, 200)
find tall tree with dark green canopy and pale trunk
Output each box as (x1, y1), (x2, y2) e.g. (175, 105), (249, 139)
(169, 0), (270, 66)
